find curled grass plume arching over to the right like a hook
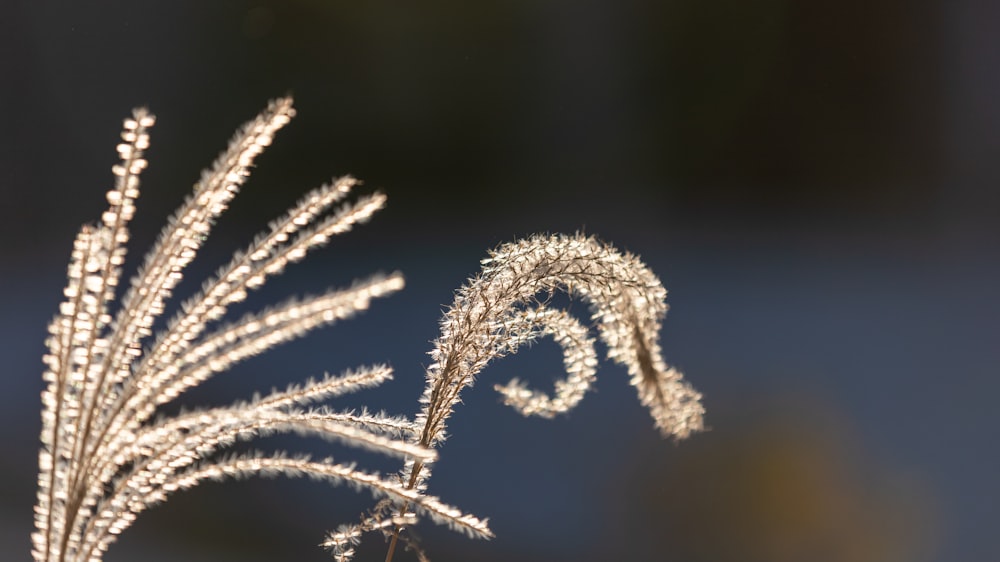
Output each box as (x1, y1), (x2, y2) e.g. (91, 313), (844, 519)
(376, 235), (704, 561)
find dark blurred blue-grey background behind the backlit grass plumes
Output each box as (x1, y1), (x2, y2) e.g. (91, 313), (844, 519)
(0, 0), (1000, 562)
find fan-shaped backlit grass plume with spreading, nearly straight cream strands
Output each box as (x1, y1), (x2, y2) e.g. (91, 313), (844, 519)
(32, 98), (464, 562)
